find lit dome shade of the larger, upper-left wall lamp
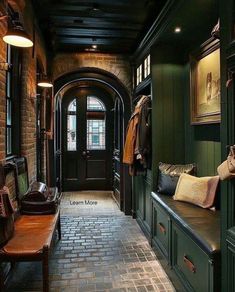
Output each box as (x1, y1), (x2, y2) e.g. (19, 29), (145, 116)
(3, 25), (33, 48)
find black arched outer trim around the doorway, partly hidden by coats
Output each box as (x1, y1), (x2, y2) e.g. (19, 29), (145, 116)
(50, 67), (132, 214)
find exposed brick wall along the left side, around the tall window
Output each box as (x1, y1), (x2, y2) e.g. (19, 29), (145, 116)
(0, 0), (46, 181)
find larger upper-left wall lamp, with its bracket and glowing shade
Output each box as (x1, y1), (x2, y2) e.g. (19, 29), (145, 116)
(0, 7), (33, 48)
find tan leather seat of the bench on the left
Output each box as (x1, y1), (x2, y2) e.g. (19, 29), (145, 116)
(0, 212), (59, 256)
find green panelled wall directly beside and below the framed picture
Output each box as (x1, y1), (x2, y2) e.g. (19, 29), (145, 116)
(184, 65), (221, 176)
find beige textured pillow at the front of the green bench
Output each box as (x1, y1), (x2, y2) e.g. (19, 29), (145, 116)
(173, 173), (219, 208)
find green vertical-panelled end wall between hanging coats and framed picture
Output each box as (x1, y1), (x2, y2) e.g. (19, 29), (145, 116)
(151, 49), (185, 189)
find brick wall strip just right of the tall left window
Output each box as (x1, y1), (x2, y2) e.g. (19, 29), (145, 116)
(21, 1), (46, 180)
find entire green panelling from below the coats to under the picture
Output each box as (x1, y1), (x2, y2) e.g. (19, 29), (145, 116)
(133, 47), (221, 240)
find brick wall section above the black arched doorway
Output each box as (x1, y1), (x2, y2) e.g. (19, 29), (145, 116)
(53, 52), (132, 92)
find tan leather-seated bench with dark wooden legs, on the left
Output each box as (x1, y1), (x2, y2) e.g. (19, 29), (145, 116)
(0, 211), (61, 292)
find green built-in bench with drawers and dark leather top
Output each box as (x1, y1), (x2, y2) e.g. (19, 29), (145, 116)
(151, 192), (220, 292)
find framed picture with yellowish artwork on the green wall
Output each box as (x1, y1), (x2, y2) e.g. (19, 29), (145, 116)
(190, 39), (221, 125)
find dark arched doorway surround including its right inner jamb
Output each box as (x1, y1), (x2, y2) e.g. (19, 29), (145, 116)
(50, 68), (132, 214)
